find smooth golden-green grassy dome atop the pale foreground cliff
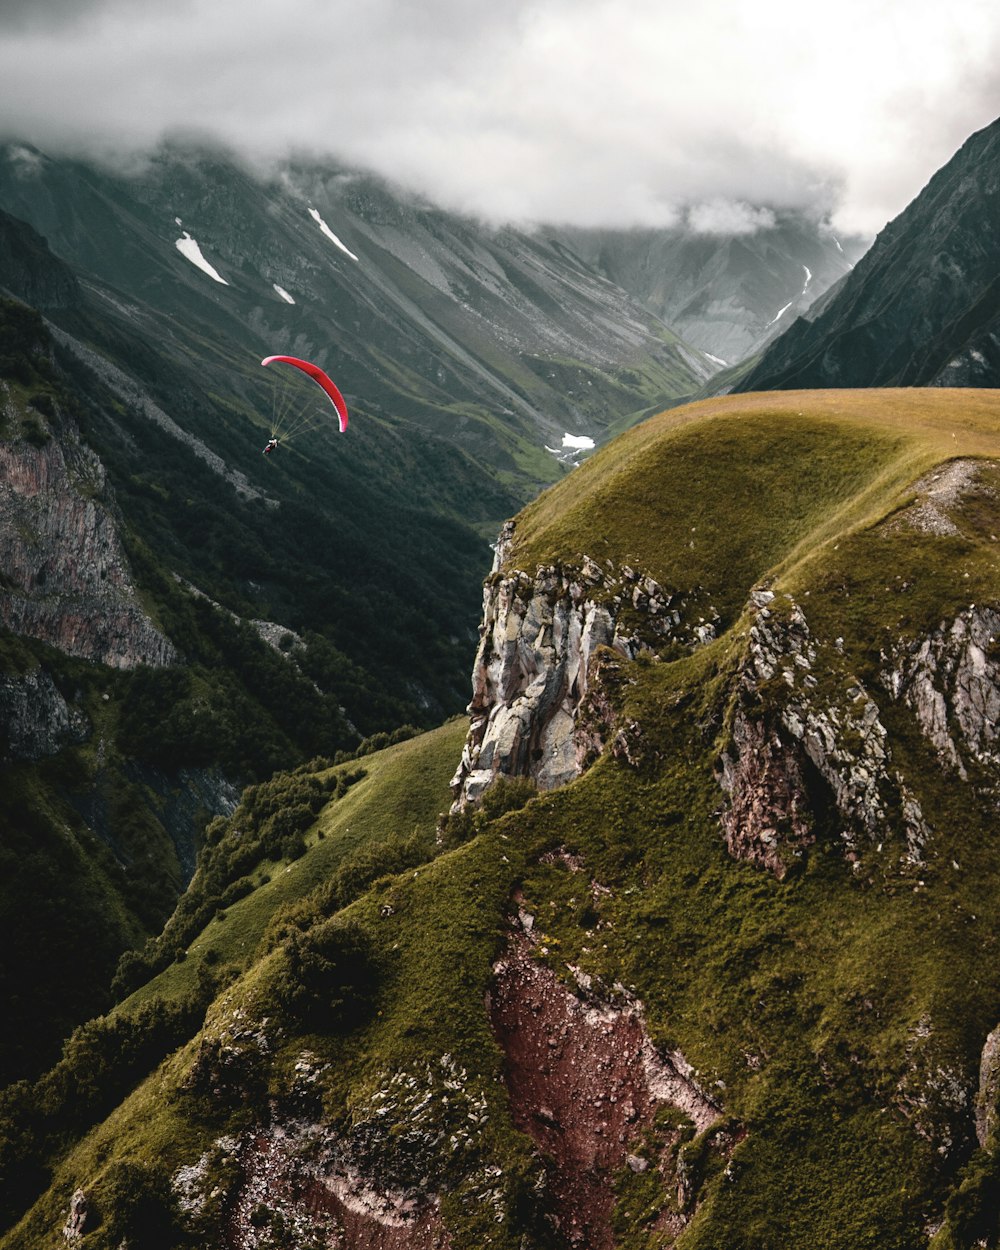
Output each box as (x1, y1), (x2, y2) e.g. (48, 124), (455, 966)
(510, 390), (1000, 619)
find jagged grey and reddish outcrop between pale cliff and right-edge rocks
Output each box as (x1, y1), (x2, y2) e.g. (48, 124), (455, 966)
(719, 590), (929, 876)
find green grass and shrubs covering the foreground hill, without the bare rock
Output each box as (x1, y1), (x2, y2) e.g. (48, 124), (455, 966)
(0, 391), (1000, 1250)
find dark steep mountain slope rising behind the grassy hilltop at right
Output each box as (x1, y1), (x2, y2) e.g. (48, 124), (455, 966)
(736, 121), (1000, 390)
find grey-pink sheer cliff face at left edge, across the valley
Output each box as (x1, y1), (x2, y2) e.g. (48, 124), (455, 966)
(0, 402), (176, 669)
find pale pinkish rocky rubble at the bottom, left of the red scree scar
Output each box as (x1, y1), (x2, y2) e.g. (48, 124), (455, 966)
(173, 1035), (457, 1250)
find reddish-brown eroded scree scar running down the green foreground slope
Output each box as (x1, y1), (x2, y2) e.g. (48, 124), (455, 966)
(488, 926), (721, 1250)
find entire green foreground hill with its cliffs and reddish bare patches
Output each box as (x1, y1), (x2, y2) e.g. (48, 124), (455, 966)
(0, 389), (1000, 1250)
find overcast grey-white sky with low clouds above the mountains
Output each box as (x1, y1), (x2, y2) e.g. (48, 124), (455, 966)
(0, 0), (1000, 234)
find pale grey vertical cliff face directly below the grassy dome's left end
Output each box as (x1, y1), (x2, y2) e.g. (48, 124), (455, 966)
(451, 523), (718, 808)
